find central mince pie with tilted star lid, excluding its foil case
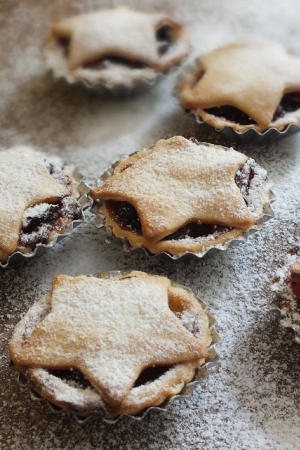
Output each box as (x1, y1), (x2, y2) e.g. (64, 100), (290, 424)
(90, 136), (270, 255)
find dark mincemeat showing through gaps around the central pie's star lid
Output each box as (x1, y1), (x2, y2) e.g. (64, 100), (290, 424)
(105, 161), (255, 240)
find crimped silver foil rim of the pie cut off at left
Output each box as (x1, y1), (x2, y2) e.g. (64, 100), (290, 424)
(0, 175), (92, 269)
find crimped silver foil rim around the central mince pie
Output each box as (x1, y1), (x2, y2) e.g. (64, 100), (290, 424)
(91, 144), (276, 260)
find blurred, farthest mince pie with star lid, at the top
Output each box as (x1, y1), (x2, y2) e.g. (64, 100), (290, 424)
(45, 7), (189, 87)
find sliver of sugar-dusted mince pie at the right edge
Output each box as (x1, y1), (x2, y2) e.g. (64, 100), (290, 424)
(272, 249), (300, 342)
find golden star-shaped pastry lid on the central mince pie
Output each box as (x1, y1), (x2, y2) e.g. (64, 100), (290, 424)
(91, 136), (254, 242)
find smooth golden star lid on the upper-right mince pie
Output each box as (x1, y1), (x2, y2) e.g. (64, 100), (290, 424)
(181, 40), (300, 130)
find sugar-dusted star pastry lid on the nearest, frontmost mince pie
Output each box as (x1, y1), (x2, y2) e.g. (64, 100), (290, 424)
(10, 274), (207, 406)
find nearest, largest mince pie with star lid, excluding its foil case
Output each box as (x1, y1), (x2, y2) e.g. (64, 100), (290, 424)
(10, 272), (211, 418)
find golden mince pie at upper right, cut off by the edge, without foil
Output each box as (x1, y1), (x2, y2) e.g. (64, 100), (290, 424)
(178, 40), (300, 132)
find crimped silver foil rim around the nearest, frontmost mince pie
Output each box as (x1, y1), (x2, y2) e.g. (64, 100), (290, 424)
(11, 270), (221, 425)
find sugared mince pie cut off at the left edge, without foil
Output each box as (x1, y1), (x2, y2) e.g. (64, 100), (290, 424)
(0, 147), (83, 264)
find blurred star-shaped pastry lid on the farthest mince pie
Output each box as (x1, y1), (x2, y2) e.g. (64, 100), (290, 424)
(52, 7), (181, 70)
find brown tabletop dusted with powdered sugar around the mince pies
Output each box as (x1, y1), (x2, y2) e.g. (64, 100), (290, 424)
(0, 0), (300, 450)
